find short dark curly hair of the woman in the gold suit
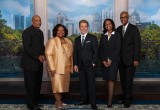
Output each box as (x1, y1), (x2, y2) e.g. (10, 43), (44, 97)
(52, 24), (68, 37)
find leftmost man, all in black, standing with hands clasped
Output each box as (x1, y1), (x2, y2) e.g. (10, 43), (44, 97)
(21, 15), (45, 110)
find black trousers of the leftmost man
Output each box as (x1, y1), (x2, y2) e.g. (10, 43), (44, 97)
(24, 69), (43, 109)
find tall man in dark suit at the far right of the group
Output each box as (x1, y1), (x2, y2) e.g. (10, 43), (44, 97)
(117, 12), (141, 108)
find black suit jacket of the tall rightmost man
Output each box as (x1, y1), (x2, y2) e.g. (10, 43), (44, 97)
(117, 23), (141, 65)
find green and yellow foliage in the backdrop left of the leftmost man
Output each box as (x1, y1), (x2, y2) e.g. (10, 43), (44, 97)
(0, 19), (22, 56)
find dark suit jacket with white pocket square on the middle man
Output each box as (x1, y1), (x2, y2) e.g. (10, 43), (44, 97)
(73, 34), (98, 68)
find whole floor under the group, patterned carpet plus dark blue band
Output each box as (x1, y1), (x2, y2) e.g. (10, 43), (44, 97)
(0, 99), (160, 110)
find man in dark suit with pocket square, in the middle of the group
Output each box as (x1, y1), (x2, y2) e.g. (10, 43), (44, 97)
(73, 20), (98, 110)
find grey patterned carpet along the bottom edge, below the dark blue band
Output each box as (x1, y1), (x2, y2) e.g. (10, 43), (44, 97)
(0, 104), (160, 110)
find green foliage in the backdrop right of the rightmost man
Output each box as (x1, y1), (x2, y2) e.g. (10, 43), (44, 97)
(140, 24), (160, 60)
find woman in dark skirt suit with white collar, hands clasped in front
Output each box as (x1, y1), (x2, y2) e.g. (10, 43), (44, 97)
(100, 19), (121, 108)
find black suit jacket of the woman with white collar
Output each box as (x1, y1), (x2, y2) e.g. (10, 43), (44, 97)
(100, 31), (121, 63)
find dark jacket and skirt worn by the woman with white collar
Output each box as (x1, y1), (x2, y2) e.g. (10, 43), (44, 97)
(100, 31), (121, 80)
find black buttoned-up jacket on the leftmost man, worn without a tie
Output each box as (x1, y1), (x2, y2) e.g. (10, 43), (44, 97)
(21, 26), (45, 71)
